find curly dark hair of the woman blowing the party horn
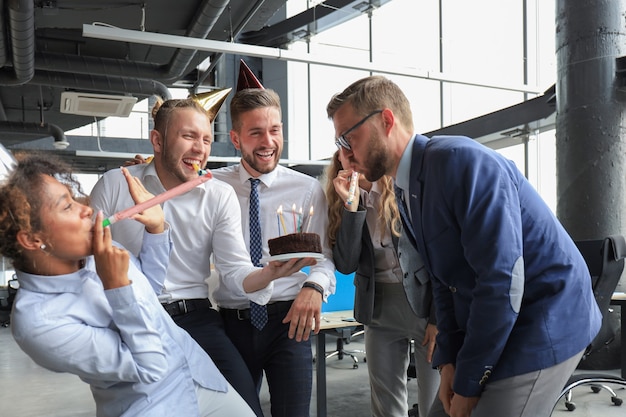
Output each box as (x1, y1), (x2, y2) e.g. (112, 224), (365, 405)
(0, 154), (87, 269)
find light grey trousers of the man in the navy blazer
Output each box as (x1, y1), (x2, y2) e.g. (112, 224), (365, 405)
(428, 351), (584, 417)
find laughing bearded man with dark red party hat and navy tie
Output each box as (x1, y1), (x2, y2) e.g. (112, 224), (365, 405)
(212, 61), (335, 417)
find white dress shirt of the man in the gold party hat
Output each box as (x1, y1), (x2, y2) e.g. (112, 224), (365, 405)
(91, 164), (258, 301)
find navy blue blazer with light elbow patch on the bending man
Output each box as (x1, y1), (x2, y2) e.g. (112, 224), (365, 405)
(405, 135), (601, 396)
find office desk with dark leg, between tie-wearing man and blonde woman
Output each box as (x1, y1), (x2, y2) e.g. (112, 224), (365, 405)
(315, 310), (361, 417)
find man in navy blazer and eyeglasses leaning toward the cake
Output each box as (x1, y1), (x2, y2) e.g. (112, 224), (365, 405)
(327, 76), (601, 417)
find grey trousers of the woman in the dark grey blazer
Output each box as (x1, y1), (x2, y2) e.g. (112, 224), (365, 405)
(365, 282), (439, 417)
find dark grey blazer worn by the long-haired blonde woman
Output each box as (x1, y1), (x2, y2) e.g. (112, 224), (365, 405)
(333, 206), (435, 324)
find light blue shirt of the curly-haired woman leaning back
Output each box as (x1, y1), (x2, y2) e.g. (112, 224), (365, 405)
(11, 232), (228, 417)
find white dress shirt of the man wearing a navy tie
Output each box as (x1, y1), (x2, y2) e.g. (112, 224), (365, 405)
(211, 164), (336, 308)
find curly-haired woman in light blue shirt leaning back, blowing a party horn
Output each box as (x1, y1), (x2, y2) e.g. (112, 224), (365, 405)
(0, 156), (254, 417)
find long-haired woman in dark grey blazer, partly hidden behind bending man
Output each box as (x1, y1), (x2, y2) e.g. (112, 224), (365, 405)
(326, 150), (439, 417)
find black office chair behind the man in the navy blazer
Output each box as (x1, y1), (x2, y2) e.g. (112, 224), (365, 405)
(557, 235), (626, 411)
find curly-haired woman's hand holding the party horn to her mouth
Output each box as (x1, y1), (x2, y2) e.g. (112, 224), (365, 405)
(92, 211), (130, 290)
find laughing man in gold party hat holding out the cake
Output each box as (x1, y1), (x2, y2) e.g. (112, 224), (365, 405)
(91, 89), (307, 416)
